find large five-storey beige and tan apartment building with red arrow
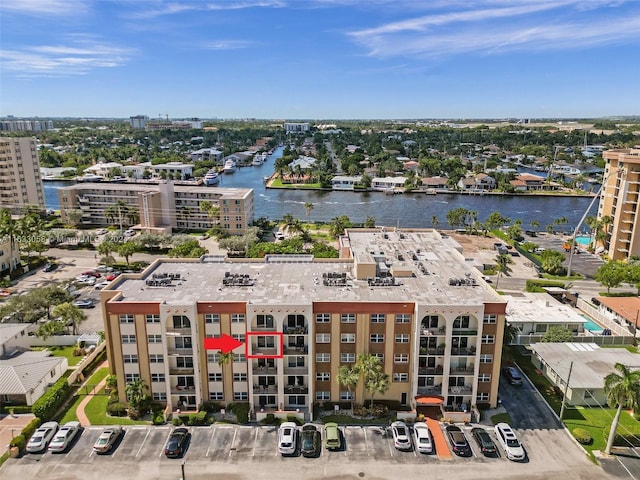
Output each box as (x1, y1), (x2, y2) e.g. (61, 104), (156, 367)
(101, 228), (506, 418)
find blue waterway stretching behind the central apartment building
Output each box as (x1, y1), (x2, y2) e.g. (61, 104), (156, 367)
(44, 149), (598, 231)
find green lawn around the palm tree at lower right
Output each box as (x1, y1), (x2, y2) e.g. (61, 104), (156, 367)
(564, 407), (640, 459)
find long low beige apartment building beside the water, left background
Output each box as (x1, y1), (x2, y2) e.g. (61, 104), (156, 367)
(58, 182), (254, 235)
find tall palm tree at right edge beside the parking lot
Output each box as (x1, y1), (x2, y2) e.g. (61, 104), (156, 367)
(604, 363), (640, 455)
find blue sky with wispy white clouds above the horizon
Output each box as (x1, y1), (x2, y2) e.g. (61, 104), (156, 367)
(0, 0), (640, 119)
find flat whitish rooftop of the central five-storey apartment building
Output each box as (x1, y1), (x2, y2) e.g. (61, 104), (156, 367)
(107, 229), (505, 305)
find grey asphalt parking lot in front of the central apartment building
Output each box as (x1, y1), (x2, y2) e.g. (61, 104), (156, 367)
(2, 424), (606, 480)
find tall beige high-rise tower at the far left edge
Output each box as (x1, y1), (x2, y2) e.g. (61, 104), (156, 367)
(0, 137), (45, 213)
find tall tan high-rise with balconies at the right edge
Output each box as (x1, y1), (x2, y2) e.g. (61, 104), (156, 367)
(598, 148), (640, 260)
